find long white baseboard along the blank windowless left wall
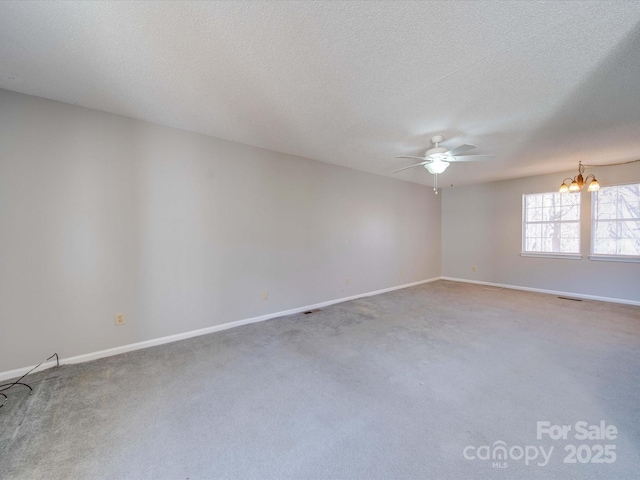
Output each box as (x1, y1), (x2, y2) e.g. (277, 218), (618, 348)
(0, 277), (441, 382)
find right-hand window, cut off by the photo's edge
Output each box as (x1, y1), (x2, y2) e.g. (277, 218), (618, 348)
(591, 183), (640, 257)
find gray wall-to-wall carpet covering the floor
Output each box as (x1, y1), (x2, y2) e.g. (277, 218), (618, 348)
(0, 281), (640, 480)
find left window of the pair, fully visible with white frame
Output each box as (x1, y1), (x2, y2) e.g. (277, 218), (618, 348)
(522, 192), (580, 255)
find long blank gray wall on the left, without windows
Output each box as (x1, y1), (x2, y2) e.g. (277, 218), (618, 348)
(0, 90), (441, 371)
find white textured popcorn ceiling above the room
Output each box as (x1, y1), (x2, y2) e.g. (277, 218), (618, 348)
(0, 0), (640, 185)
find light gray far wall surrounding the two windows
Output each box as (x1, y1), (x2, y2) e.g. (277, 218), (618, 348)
(442, 162), (640, 301)
